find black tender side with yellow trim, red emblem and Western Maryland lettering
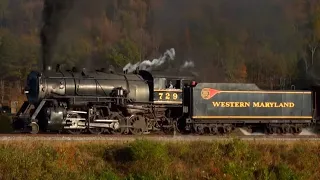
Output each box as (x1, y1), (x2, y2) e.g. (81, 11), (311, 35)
(192, 83), (312, 120)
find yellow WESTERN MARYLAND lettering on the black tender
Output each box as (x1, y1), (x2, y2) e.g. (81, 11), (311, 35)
(212, 102), (295, 108)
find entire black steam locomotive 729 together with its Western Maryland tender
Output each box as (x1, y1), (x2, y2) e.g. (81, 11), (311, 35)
(13, 64), (319, 134)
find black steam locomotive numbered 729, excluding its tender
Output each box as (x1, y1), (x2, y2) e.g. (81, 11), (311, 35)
(13, 65), (194, 134)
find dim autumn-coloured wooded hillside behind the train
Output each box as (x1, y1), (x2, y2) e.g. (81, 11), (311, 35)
(0, 0), (320, 87)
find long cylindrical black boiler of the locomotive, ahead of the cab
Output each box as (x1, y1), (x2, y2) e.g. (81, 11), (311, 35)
(25, 71), (150, 104)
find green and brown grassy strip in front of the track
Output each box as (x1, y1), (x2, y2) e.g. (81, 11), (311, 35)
(0, 140), (320, 180)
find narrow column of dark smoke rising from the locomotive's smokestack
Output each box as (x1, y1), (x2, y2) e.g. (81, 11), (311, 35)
(40, 0), (74, 70)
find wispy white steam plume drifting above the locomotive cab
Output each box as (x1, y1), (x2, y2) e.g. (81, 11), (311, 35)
(123, 48), (176, 73)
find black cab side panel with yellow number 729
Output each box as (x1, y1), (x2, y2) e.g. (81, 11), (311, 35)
(153, 89), (182, 104)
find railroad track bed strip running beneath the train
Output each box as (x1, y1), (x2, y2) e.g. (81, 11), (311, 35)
(0, 134), (320, 142)
